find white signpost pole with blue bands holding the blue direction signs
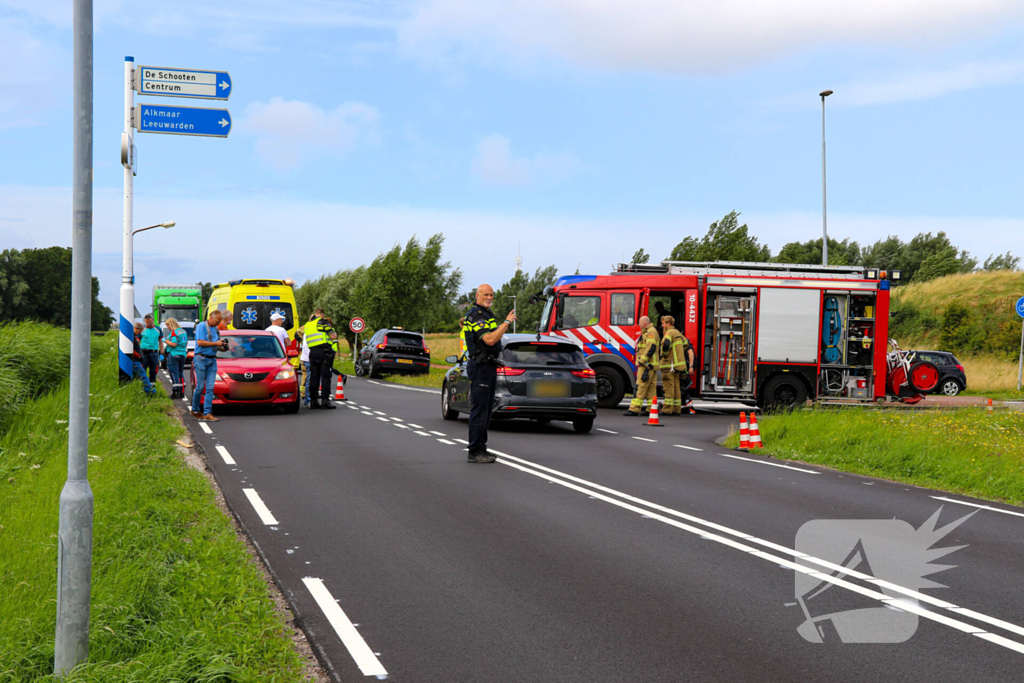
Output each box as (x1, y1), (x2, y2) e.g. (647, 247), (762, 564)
(118, 57), (135, 384)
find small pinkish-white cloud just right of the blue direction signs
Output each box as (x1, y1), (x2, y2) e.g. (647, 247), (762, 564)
(239, 97), (380, 169)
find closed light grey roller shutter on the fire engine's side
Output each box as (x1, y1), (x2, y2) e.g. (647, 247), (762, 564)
(758, 287), (821, 362)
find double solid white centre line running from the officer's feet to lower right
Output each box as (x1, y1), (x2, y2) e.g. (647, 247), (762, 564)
(492, 450), (1024, 653)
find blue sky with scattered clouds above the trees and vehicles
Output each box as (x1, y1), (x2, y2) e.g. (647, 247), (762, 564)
(0, 0), (1024, 315)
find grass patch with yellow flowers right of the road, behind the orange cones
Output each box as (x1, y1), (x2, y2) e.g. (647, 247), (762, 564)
(725, 409), (1024, 505)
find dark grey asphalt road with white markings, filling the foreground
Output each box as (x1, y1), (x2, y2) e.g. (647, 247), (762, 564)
(163, 378), (1024, 683)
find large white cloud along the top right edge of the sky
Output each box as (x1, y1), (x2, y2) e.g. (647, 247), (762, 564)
(399, 0), (1024, 74)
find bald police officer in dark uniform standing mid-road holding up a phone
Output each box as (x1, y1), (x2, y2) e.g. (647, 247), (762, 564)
(462, 285), (515, 463)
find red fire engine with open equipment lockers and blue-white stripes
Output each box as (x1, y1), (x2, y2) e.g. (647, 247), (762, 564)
(540, 261), (938, 408)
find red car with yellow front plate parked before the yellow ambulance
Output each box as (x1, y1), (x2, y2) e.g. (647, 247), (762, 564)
(191, 330), (302, 413)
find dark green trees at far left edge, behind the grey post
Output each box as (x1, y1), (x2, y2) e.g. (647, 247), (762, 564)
(0, 247), (114, 331)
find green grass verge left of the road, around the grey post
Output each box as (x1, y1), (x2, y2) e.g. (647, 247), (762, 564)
(0, 335), (302, 683)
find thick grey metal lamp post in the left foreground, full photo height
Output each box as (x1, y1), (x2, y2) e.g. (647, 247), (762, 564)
(53, 0), (92, 677)
